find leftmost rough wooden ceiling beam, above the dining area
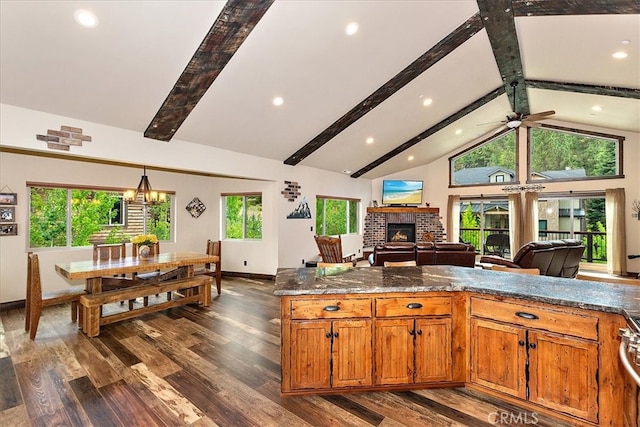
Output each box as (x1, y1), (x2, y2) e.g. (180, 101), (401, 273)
(144, 0), (274, 141)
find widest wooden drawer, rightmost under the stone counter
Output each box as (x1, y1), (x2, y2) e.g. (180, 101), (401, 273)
(471, 298), (598, 340)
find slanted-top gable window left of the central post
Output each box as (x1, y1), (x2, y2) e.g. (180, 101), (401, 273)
(449, 129), (517, 186)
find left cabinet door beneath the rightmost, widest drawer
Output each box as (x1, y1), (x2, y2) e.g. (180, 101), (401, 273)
(471, 319), (527, 399)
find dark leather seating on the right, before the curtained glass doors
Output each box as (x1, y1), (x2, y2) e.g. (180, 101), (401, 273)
(480, 239), (584, 278)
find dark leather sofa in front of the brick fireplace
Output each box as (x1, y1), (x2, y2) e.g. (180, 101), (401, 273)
(369, 242), (476, 268)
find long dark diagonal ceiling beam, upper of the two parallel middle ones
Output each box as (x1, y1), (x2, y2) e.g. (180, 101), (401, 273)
(284, 14), (482, 165)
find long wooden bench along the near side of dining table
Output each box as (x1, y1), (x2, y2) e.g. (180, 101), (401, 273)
(80, 276), (213, 337)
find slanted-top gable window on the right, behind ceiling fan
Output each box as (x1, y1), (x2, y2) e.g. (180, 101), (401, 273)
(529, 125), (624, 181)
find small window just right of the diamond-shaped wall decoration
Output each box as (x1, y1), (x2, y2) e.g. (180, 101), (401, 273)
(222, 193), (262, 239)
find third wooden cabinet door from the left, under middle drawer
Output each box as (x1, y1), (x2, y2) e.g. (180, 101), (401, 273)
(375, 319), (414, 385)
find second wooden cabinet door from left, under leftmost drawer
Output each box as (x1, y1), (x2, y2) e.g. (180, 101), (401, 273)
(332, 320), (373, 387)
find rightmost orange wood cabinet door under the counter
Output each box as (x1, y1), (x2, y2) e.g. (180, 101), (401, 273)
(529, 331), (598, 422)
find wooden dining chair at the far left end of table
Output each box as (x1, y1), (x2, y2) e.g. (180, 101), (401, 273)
(24, 252), (86, 340)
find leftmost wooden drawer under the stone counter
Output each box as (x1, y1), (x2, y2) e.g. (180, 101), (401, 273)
(291, 298), (371, 319)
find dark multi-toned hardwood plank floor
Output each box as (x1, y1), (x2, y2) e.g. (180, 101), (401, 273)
(0, 277), (561, 427)
